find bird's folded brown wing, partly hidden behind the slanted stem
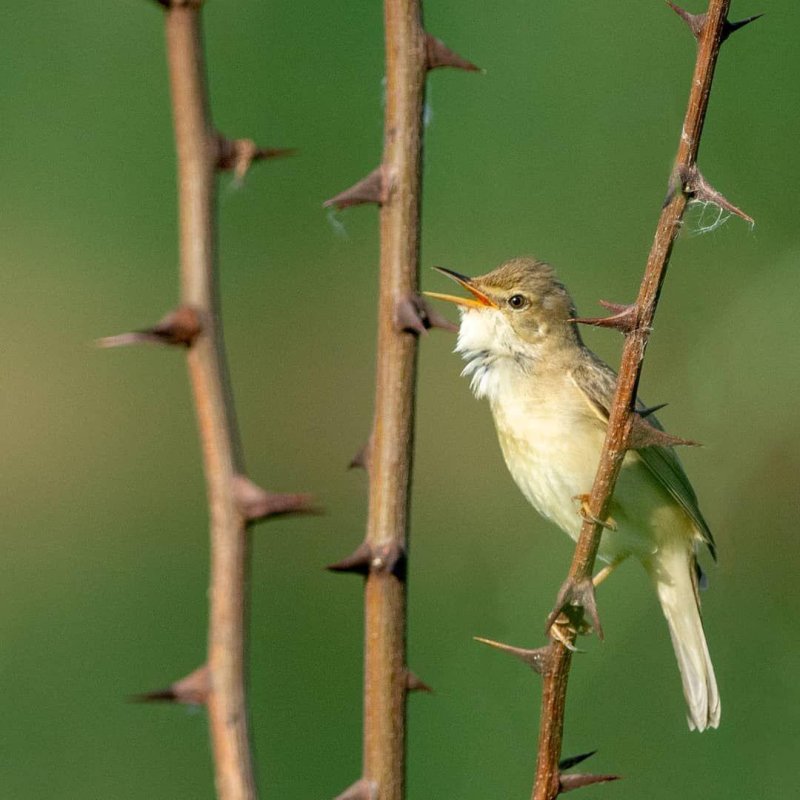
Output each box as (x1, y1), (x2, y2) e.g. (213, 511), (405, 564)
(571, 350), (717, 560)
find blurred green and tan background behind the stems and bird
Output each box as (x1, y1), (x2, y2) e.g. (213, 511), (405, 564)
(0, 0), (800, 800)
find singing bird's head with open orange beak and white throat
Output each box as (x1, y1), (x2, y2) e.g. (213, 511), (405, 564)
(425, 258), (580, 357)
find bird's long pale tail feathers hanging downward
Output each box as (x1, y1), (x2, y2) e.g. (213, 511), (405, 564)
(649, 547), (721, 731)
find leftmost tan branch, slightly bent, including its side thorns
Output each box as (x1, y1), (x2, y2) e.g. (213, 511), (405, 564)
(100, 0), (311, 800)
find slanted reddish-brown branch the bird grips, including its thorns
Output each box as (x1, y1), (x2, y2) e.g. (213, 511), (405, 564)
(532, 0), (752, 800)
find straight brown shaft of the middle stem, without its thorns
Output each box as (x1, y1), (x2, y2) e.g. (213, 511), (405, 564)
(364, 0), (426, 800)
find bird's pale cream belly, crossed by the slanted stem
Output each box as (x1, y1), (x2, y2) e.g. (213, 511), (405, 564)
(492, 395), (693, 561)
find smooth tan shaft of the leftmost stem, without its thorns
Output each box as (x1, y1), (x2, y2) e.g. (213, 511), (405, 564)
(160, 0), (256, 800)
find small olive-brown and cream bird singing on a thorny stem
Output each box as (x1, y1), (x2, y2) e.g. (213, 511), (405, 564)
(425, 257), (721, 731)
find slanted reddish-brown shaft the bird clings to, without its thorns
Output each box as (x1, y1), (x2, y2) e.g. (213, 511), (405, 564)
(532, 0), (730, 800)
